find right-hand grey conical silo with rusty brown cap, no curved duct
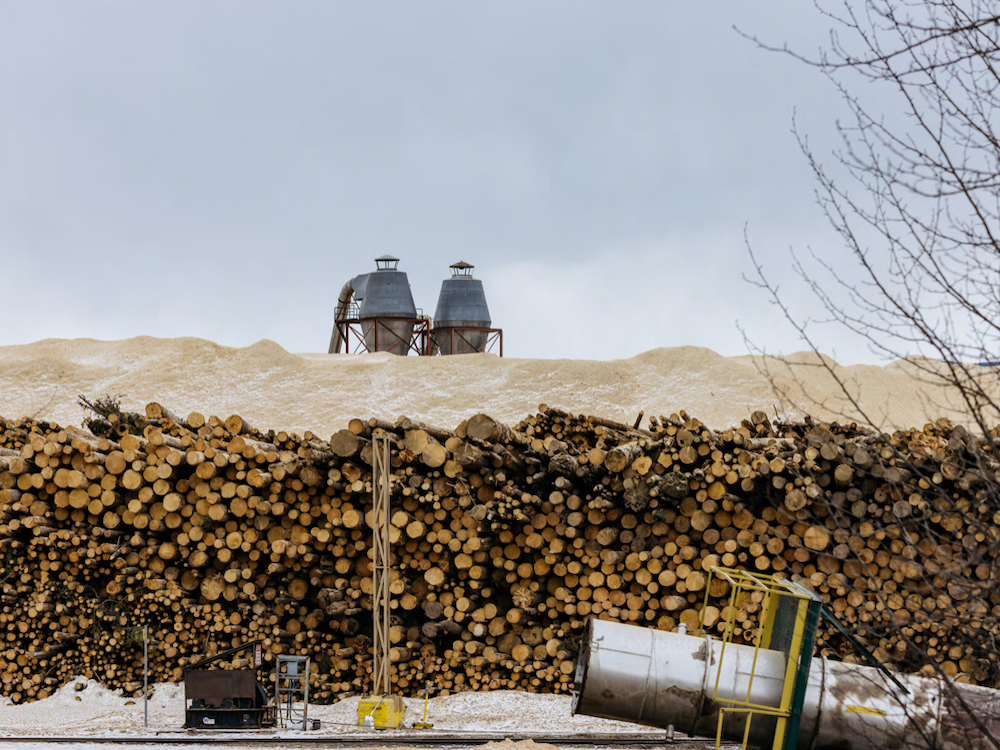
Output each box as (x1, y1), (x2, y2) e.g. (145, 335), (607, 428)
(431, 261), (491, 354)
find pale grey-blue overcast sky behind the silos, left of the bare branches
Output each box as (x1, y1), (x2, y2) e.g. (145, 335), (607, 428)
(0, 0), (874, 362)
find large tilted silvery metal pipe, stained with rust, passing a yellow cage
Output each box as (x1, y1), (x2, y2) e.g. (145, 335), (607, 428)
(573, 619), (1000, 750)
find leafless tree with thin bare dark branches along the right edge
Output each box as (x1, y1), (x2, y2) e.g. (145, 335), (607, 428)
(748, 0), (1000, 746)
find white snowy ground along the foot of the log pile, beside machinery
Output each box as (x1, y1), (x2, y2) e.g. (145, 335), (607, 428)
(0, 677), (663, 742)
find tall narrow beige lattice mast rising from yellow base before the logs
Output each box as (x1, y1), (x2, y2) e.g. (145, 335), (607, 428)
(372, 435), (392, 695)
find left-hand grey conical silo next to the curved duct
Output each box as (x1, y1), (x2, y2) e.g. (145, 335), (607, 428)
(353, 255), (417, 356)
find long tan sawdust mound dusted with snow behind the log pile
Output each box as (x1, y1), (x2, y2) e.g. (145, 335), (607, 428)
(0, 336), (988, 436)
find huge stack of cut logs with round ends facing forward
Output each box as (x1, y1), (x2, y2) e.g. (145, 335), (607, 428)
(0, 401), (1000, 702)
